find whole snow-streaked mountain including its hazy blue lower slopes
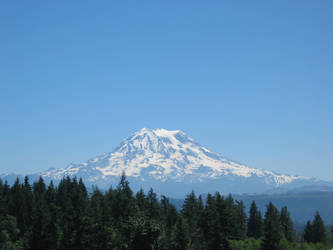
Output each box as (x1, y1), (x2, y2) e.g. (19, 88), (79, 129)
(1, 128), (332, 197)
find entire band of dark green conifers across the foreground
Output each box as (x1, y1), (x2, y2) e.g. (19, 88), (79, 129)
(0, 175), (333, 250)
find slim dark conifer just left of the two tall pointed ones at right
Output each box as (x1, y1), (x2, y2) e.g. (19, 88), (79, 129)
(247, 201), (263, 239)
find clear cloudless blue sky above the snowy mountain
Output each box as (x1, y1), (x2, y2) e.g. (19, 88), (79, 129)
(0, 0), (333, 181)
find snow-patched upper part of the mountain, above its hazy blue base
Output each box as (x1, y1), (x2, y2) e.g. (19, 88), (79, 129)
(43, 128), (312, 186)
